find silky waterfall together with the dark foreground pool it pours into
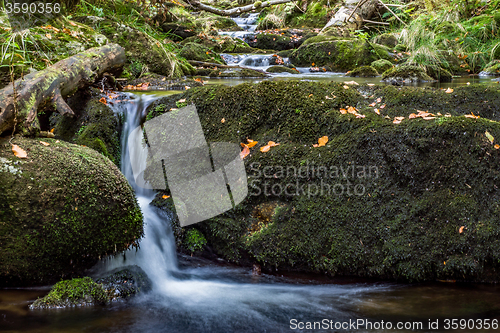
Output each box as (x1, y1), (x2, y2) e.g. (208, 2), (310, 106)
(0, 94), (500, 333)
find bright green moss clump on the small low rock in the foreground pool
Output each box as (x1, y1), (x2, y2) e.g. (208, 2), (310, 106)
(30, 277), (108, 309)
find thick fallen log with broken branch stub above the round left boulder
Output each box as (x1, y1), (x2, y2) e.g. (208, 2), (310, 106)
(0, 44), (126, 135)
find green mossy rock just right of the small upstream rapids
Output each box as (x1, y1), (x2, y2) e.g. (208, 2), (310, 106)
(290, 37), (389, 71)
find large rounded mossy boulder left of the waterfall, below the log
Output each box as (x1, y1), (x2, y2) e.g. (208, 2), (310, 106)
(0, 137), (143, 286)
